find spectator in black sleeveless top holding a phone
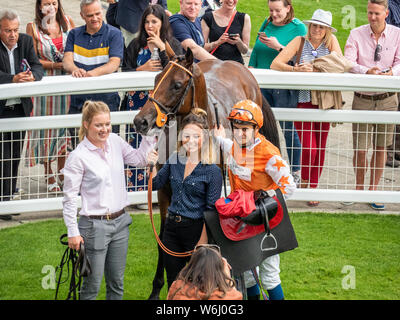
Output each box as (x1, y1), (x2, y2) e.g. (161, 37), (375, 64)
(201, 0), (251, 64)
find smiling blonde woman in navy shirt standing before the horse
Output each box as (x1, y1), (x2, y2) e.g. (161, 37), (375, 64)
(148, 108), (222, 287)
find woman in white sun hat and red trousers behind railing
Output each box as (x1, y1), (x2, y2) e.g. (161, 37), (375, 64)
(271, 9), (343, 206)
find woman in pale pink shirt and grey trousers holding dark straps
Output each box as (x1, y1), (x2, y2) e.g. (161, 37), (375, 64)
(63, 101), (155, 300)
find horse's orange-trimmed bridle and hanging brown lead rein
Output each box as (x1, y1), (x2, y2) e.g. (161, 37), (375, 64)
(147, 61), (194, 258)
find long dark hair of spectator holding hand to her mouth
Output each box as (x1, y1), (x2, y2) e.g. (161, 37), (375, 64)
(133, 4), (172, 53)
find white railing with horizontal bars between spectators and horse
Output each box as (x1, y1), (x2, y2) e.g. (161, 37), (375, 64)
(0, 69), (400, 214)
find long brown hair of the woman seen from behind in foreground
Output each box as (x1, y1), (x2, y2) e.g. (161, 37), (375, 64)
(171, 247), (235, 300)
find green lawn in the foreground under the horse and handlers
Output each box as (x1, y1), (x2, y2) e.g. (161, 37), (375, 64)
(0, 213), (400, 300)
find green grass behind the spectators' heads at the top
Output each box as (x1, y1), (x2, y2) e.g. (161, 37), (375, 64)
(168, 0), (368, 50)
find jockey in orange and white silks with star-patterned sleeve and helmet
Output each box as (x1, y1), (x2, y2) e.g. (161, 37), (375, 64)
(214, 100), (296, 300)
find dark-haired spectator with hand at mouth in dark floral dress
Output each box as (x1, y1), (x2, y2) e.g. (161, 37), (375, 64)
(120, 4), (183, 198)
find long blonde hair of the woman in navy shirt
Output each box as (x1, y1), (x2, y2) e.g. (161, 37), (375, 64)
(178, 108), (216, 164)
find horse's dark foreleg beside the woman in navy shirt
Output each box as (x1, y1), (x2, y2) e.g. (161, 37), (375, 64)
(148, 186), (171, 300)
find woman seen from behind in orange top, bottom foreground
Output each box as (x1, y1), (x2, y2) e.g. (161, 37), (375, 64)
(167, 244), (242, 300)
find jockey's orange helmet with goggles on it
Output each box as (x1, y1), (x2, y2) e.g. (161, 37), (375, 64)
(228, 100), (264, 128)
